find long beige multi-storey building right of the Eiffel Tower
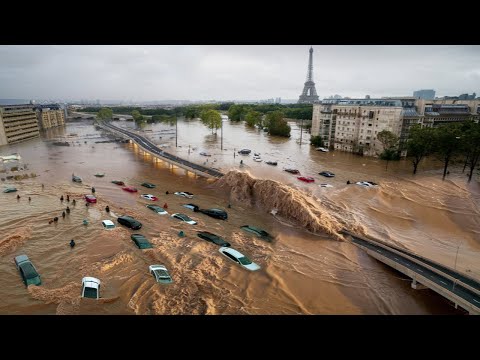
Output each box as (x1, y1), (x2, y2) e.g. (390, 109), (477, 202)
(311, 97), (480, 156)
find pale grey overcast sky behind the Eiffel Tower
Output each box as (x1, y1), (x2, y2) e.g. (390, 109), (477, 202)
(0, 45), (480, 101)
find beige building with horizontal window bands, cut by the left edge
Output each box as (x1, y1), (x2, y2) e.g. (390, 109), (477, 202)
(0, 104), (39, 145)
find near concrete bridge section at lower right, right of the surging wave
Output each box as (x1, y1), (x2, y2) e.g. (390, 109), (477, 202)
(344, 231), (480, 315)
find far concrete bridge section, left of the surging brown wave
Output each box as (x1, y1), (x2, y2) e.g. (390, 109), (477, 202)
(97, 122), (224, 179)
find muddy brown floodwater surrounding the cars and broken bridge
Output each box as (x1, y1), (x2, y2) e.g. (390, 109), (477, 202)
(0, 120), (480, 314)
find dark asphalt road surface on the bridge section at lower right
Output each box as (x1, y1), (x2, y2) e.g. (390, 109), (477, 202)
(352, 235), (480, 310)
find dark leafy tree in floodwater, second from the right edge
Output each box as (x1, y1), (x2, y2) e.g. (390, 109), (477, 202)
(433, 123), (462, 179)
